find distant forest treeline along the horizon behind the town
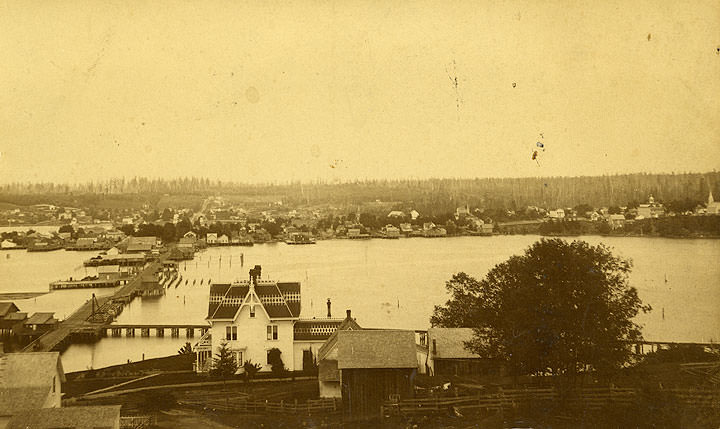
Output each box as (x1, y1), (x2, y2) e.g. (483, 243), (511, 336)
(0, 172), (720, 213)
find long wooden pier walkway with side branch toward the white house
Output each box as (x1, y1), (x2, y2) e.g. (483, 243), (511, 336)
(23, 252), (209, 352)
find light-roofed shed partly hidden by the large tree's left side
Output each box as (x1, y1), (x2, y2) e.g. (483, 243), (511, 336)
(427, 328), (504, 376)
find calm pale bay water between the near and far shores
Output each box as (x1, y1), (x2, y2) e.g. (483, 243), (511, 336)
(0, 236), (720, 371)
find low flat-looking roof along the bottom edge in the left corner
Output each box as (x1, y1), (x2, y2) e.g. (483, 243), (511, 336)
(7, 405), (121, 429)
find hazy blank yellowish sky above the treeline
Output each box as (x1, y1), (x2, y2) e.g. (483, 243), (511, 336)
(0, 0), (720, 182)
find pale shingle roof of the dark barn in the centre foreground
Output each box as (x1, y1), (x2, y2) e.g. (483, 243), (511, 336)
(337, 329), (417, 369)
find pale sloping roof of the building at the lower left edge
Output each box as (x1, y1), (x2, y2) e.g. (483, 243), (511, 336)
(0, 352), (65, 389)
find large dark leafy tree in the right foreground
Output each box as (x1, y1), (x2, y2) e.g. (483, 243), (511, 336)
(431, 239), (650, 375)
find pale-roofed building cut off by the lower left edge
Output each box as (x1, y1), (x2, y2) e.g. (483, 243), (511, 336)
(0, 352), (66, 422)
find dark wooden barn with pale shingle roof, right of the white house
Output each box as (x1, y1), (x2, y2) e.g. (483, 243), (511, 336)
(337, 330), (417, 420)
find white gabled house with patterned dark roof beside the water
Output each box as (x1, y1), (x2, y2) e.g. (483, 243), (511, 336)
(194, 265), (342, 372)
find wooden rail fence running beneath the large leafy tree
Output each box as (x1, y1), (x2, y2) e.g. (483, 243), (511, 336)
(380, 387), (720, 416)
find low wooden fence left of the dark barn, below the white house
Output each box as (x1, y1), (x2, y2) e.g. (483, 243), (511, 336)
(181, 397), (341, 414)
